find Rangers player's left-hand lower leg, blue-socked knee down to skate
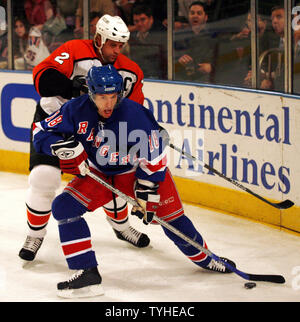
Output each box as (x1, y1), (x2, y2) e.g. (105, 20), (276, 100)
(52, 192), (103, 298)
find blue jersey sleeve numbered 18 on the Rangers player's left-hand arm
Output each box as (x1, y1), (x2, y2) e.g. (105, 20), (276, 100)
(32, 102), (74, 155)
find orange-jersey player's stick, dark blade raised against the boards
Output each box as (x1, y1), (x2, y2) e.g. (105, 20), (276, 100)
(163, 137), (294, 209)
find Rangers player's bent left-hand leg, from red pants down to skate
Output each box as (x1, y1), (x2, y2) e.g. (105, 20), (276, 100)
(52, 177), (110, 297)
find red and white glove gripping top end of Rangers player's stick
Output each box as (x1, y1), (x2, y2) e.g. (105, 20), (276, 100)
(51, 140), (88, 176)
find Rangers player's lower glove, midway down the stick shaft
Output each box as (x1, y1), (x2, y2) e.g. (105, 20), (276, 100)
(131, 179), (160, 225)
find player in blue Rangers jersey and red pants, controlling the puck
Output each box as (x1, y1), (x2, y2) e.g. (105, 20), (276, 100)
(33, 65), (234, 297)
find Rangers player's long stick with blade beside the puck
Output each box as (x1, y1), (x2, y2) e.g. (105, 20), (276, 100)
(87, 171), (285, 284)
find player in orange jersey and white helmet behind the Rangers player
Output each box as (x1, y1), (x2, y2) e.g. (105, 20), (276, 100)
(19, 15), (150, 261)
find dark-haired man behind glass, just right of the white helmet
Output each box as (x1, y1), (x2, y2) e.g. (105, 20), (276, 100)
(129, 5), (167, 79)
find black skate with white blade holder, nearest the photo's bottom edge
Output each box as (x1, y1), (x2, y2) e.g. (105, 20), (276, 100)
(57, 267), (104, 298)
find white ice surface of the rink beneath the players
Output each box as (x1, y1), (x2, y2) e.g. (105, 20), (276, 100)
(0, 172), (300, 303)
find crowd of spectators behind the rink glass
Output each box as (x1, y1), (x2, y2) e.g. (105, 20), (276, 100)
(0, 0), (300, 90)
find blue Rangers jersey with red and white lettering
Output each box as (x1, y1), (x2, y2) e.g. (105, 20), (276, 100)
(33, 94), (167, 182)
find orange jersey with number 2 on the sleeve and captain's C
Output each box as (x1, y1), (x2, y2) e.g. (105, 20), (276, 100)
(33, 39), (144, 104)
